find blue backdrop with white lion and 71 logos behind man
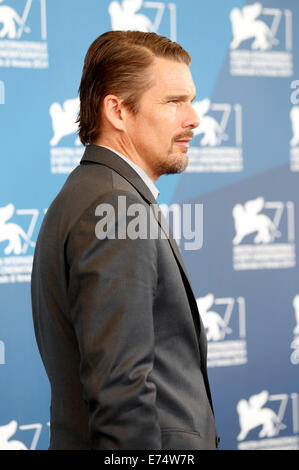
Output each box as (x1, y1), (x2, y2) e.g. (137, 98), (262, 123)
(0, 0), (299, 449)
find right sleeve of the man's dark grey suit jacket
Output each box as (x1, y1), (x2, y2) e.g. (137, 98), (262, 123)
(66, 190), (161, 449)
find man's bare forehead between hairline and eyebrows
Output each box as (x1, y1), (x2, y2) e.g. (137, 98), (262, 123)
(151, 57), (195, 98)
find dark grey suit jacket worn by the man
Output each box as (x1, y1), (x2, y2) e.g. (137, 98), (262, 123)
(31, 145), (219, 450)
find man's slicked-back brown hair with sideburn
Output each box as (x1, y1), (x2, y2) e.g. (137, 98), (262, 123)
(77, 31), (191, 145)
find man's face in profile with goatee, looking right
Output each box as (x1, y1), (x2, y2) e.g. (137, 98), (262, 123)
(126, 58), (199, 181)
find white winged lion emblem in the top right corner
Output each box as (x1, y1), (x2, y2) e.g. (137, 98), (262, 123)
(230, 2), (278, 51)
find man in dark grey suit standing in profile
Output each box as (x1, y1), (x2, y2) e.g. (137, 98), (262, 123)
(32, 31), (219, 450)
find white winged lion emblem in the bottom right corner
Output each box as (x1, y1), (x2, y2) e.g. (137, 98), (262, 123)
(237, 390), (286, 441)
